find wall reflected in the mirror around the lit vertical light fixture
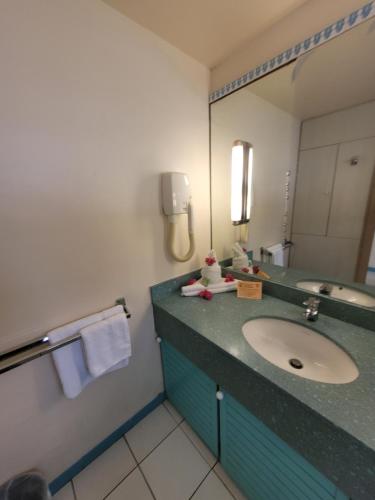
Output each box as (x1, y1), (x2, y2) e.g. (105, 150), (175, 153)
(211, 88), (300, 258)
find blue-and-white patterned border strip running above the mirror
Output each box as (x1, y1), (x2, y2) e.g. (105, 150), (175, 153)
(209, 1), (375, 103)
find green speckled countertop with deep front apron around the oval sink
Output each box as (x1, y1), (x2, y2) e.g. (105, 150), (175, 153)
(152, 274), (375, 499)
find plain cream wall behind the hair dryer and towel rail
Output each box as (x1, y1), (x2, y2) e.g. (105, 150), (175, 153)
(0, 0), (209, 482)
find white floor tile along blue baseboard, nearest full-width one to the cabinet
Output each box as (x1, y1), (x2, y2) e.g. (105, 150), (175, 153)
(126, 405), (177, 462)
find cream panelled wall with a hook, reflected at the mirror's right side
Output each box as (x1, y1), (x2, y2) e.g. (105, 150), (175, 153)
(290, 101), (375, 281)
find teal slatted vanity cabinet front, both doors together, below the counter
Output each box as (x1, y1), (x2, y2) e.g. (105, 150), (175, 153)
(161, 340), (348, 500)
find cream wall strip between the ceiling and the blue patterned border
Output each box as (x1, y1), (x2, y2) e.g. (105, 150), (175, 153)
(211, 0), (367, 90)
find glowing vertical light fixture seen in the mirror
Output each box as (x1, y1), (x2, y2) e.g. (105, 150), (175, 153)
(231, 140), (253, 226)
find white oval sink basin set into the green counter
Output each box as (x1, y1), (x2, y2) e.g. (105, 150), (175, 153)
(242, 318), (359, 384)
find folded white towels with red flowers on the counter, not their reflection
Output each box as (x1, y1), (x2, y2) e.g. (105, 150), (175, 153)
(181, 250), (238, 300)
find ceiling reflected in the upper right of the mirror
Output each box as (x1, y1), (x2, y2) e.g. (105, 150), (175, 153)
(246, 21), (375, 120)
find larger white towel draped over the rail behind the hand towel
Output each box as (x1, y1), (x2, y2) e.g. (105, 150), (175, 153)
(48, 305), (127, 399)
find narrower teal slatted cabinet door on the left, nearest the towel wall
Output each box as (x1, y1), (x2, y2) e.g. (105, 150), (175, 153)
(161, 340), (219, 457)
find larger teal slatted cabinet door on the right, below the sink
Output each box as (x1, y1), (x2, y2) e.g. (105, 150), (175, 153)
(220, 393), (348, 500)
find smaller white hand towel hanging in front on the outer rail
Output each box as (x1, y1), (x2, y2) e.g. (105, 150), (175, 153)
(81, 312), (131, 378)
